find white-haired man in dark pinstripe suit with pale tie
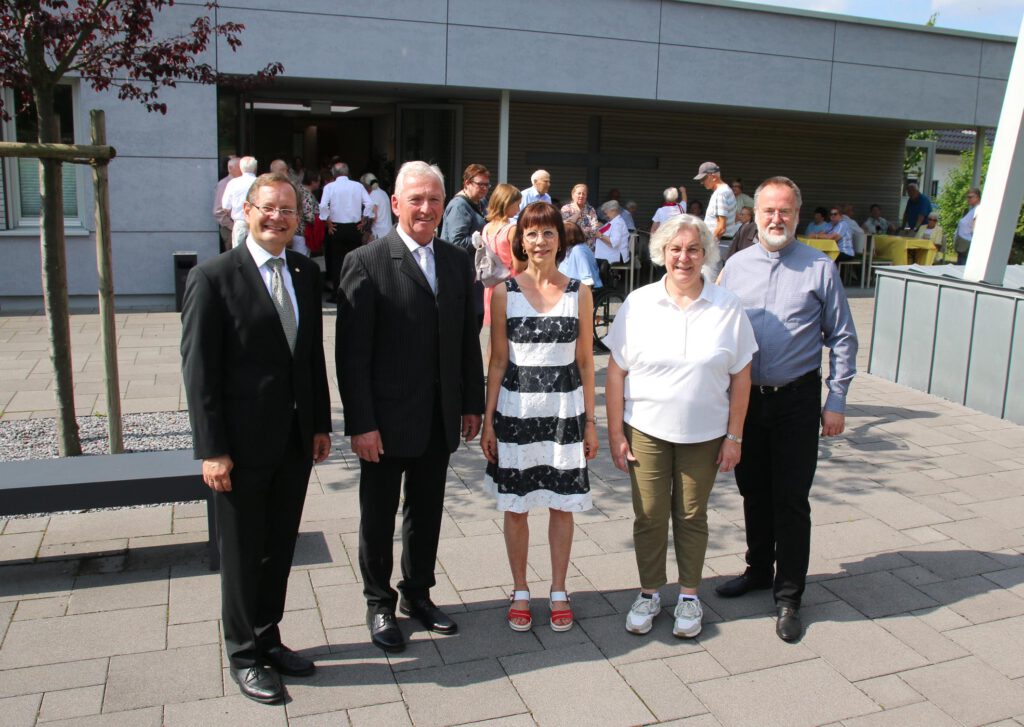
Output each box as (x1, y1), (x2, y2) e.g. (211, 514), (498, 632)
(336, 162), (483, 651)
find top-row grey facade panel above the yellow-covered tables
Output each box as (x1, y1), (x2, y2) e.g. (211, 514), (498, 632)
(835, 23), (982, 76)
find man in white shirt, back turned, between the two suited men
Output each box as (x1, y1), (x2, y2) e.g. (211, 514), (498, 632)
(321, 162), (373, 302)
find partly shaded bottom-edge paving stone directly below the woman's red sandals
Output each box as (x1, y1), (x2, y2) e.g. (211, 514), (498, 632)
(499, 645), (651, 725)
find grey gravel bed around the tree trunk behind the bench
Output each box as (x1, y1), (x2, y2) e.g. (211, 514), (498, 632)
(0, 412), (191, 462)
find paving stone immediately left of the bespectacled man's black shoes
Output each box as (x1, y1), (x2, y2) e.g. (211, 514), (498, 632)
(103, 644), (223, 713)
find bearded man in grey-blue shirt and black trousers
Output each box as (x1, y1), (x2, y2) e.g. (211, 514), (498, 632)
(715, 176), (857, 641)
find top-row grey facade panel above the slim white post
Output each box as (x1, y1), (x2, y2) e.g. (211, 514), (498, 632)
(449, 0), (658, 42)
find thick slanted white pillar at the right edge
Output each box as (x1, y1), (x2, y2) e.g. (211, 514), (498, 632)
(964, 23), (1024, 285)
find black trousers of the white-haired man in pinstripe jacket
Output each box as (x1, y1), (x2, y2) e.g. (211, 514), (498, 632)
(359, 402), (451, 613)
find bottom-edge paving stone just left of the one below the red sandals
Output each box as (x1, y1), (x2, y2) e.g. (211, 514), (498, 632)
(396, 658), (526, 727)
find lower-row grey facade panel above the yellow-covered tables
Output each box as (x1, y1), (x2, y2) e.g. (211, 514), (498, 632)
(828, 63), (978, 125)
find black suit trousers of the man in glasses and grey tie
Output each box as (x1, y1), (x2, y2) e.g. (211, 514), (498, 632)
(214, 417), (312, 669)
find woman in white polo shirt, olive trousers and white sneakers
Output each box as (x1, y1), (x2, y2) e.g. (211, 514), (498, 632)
(604, 215), (758, 638)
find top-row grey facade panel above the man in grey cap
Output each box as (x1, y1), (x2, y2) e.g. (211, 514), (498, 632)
(662, 2), (836, 60)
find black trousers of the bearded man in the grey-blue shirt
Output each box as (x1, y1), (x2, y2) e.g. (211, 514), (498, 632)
(736, 377), (821, 606)
